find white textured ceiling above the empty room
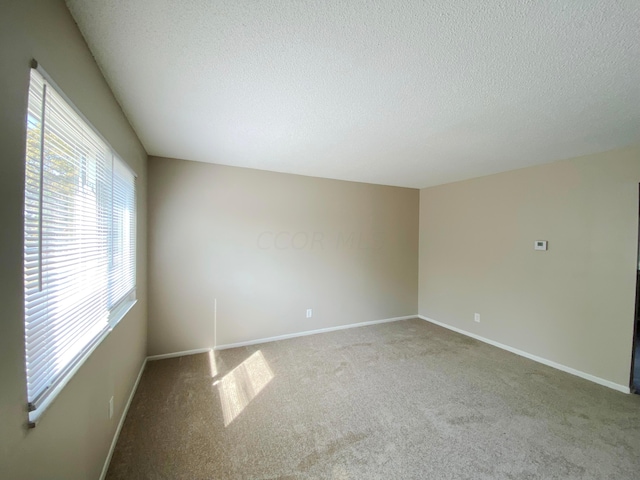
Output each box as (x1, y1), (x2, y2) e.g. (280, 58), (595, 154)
(67, 0), (640, 187)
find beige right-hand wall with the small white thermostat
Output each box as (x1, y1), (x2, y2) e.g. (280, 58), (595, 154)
(419, 148), (640, 386)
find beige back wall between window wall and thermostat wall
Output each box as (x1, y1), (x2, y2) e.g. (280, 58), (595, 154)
(149, 157), (419, 354)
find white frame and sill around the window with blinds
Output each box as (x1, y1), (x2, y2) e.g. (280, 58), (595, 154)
(22, 60), (139, 428)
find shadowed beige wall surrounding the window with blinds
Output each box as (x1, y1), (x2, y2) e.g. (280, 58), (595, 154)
(0, 0), (146, 480)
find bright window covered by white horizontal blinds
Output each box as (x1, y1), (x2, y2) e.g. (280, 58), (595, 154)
(24, 65), (136, 426)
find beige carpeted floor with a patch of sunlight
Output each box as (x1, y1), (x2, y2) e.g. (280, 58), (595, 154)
(107, 319), (640, 480)
